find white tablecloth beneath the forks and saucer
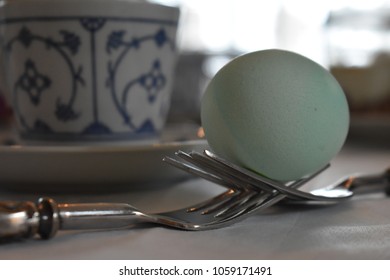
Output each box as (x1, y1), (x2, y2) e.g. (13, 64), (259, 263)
(0, 134), (390, 260)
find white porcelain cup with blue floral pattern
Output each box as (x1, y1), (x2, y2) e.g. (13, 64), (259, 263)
(0, 0), (179, 143)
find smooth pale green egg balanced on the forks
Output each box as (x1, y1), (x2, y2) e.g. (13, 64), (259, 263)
(201, 49), (349, 181)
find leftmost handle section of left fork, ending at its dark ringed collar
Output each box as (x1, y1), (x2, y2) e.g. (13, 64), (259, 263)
(0, 198), (59, 241)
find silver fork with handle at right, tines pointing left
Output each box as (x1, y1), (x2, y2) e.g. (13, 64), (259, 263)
(164, 150), (390, 227)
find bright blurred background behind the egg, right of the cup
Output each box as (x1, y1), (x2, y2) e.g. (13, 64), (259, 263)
(147, 0), (390, 144)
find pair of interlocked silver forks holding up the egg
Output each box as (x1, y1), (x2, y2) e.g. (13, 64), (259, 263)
(0, 151), (390, 241)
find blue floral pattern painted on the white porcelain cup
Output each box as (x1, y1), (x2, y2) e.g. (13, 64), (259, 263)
(0, 17), (177, 140)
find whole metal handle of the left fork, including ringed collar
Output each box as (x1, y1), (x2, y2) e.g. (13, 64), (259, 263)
(0, 198), (142, 241)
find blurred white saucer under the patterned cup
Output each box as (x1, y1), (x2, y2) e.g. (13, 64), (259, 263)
(0, 140), (207, 192)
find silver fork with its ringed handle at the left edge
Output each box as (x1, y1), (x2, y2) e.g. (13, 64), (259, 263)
(0, 162), (323, 241)
